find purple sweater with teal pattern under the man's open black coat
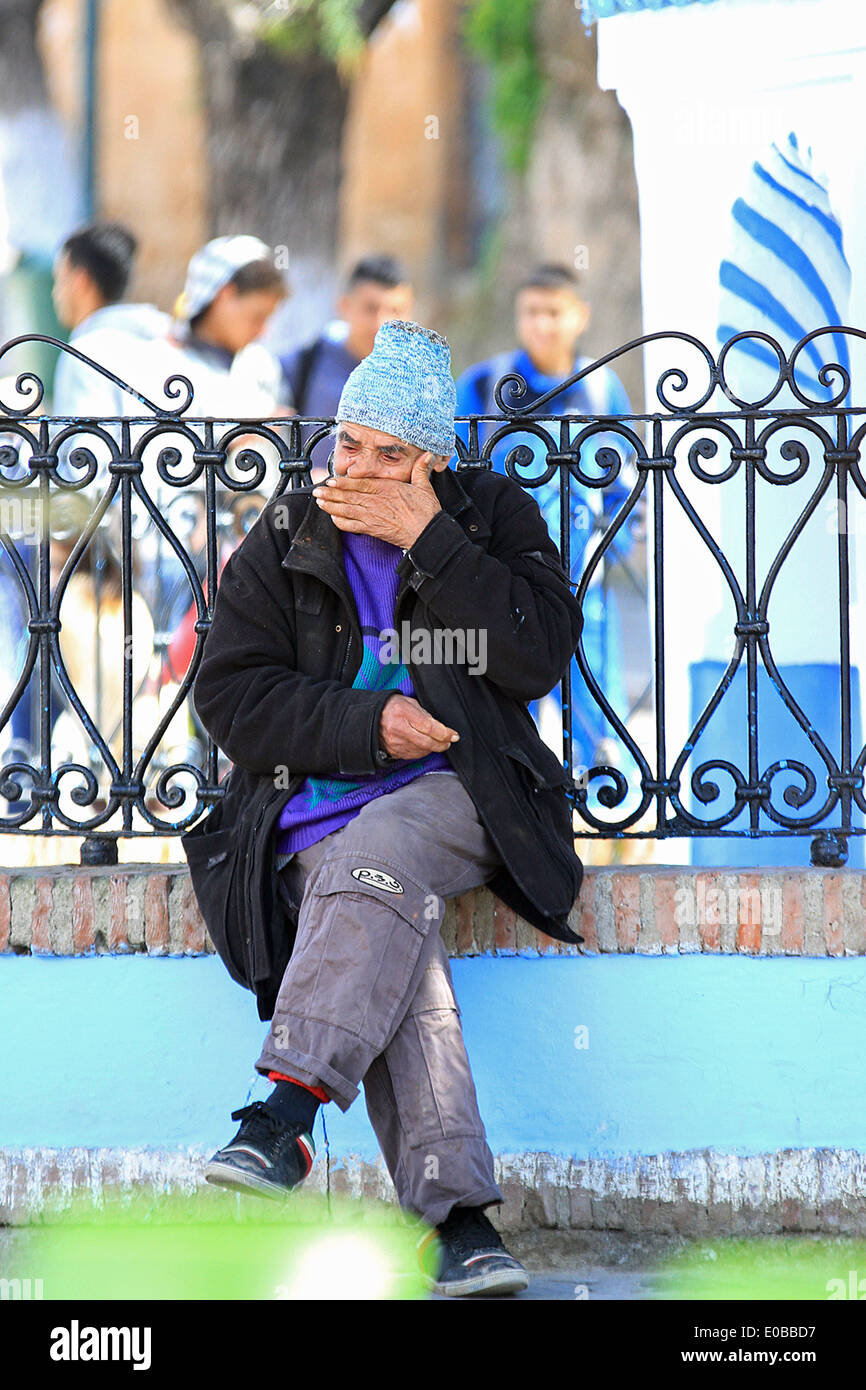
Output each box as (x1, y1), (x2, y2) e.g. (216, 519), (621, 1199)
(275, 531), (453, 867)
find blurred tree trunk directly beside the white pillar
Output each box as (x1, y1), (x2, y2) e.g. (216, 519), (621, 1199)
(449, 0), (644, 402)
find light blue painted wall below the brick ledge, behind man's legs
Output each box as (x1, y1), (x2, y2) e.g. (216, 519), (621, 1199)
(0, 956), (866, 1159)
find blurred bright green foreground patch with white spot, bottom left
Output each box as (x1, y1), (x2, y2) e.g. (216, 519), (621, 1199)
(0, 1191), (428, 1300)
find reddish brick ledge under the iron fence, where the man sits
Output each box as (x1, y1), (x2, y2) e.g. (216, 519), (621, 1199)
(0, 865), (866, 956)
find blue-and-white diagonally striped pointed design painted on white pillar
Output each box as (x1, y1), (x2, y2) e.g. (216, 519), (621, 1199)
(717, 132), (851, 403)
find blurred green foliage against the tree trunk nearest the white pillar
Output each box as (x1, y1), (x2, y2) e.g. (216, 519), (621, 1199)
(463, 0), (546, 172)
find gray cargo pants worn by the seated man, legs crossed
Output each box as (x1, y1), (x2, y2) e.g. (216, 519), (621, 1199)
(256, 773), (505, 1226)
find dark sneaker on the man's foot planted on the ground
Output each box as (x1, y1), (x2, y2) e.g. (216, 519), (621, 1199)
(418, 1207), (530, 1298)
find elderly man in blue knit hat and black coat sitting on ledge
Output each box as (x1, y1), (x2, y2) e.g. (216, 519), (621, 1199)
(185, 321), (582, 1295)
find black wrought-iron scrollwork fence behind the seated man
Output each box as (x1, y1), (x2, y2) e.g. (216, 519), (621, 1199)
(0, 327), (866, 859)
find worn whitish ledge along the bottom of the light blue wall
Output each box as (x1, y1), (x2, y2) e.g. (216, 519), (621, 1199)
(0, 1148), (866, 1237)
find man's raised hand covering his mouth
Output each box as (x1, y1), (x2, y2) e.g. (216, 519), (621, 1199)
(313, 453), (442, 550)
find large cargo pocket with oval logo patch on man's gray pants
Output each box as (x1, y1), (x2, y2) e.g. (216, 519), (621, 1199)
(301, 851), (439, 1052)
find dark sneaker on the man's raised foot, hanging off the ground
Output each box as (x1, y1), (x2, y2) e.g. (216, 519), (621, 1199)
(204, 1101), (316, 1197)
